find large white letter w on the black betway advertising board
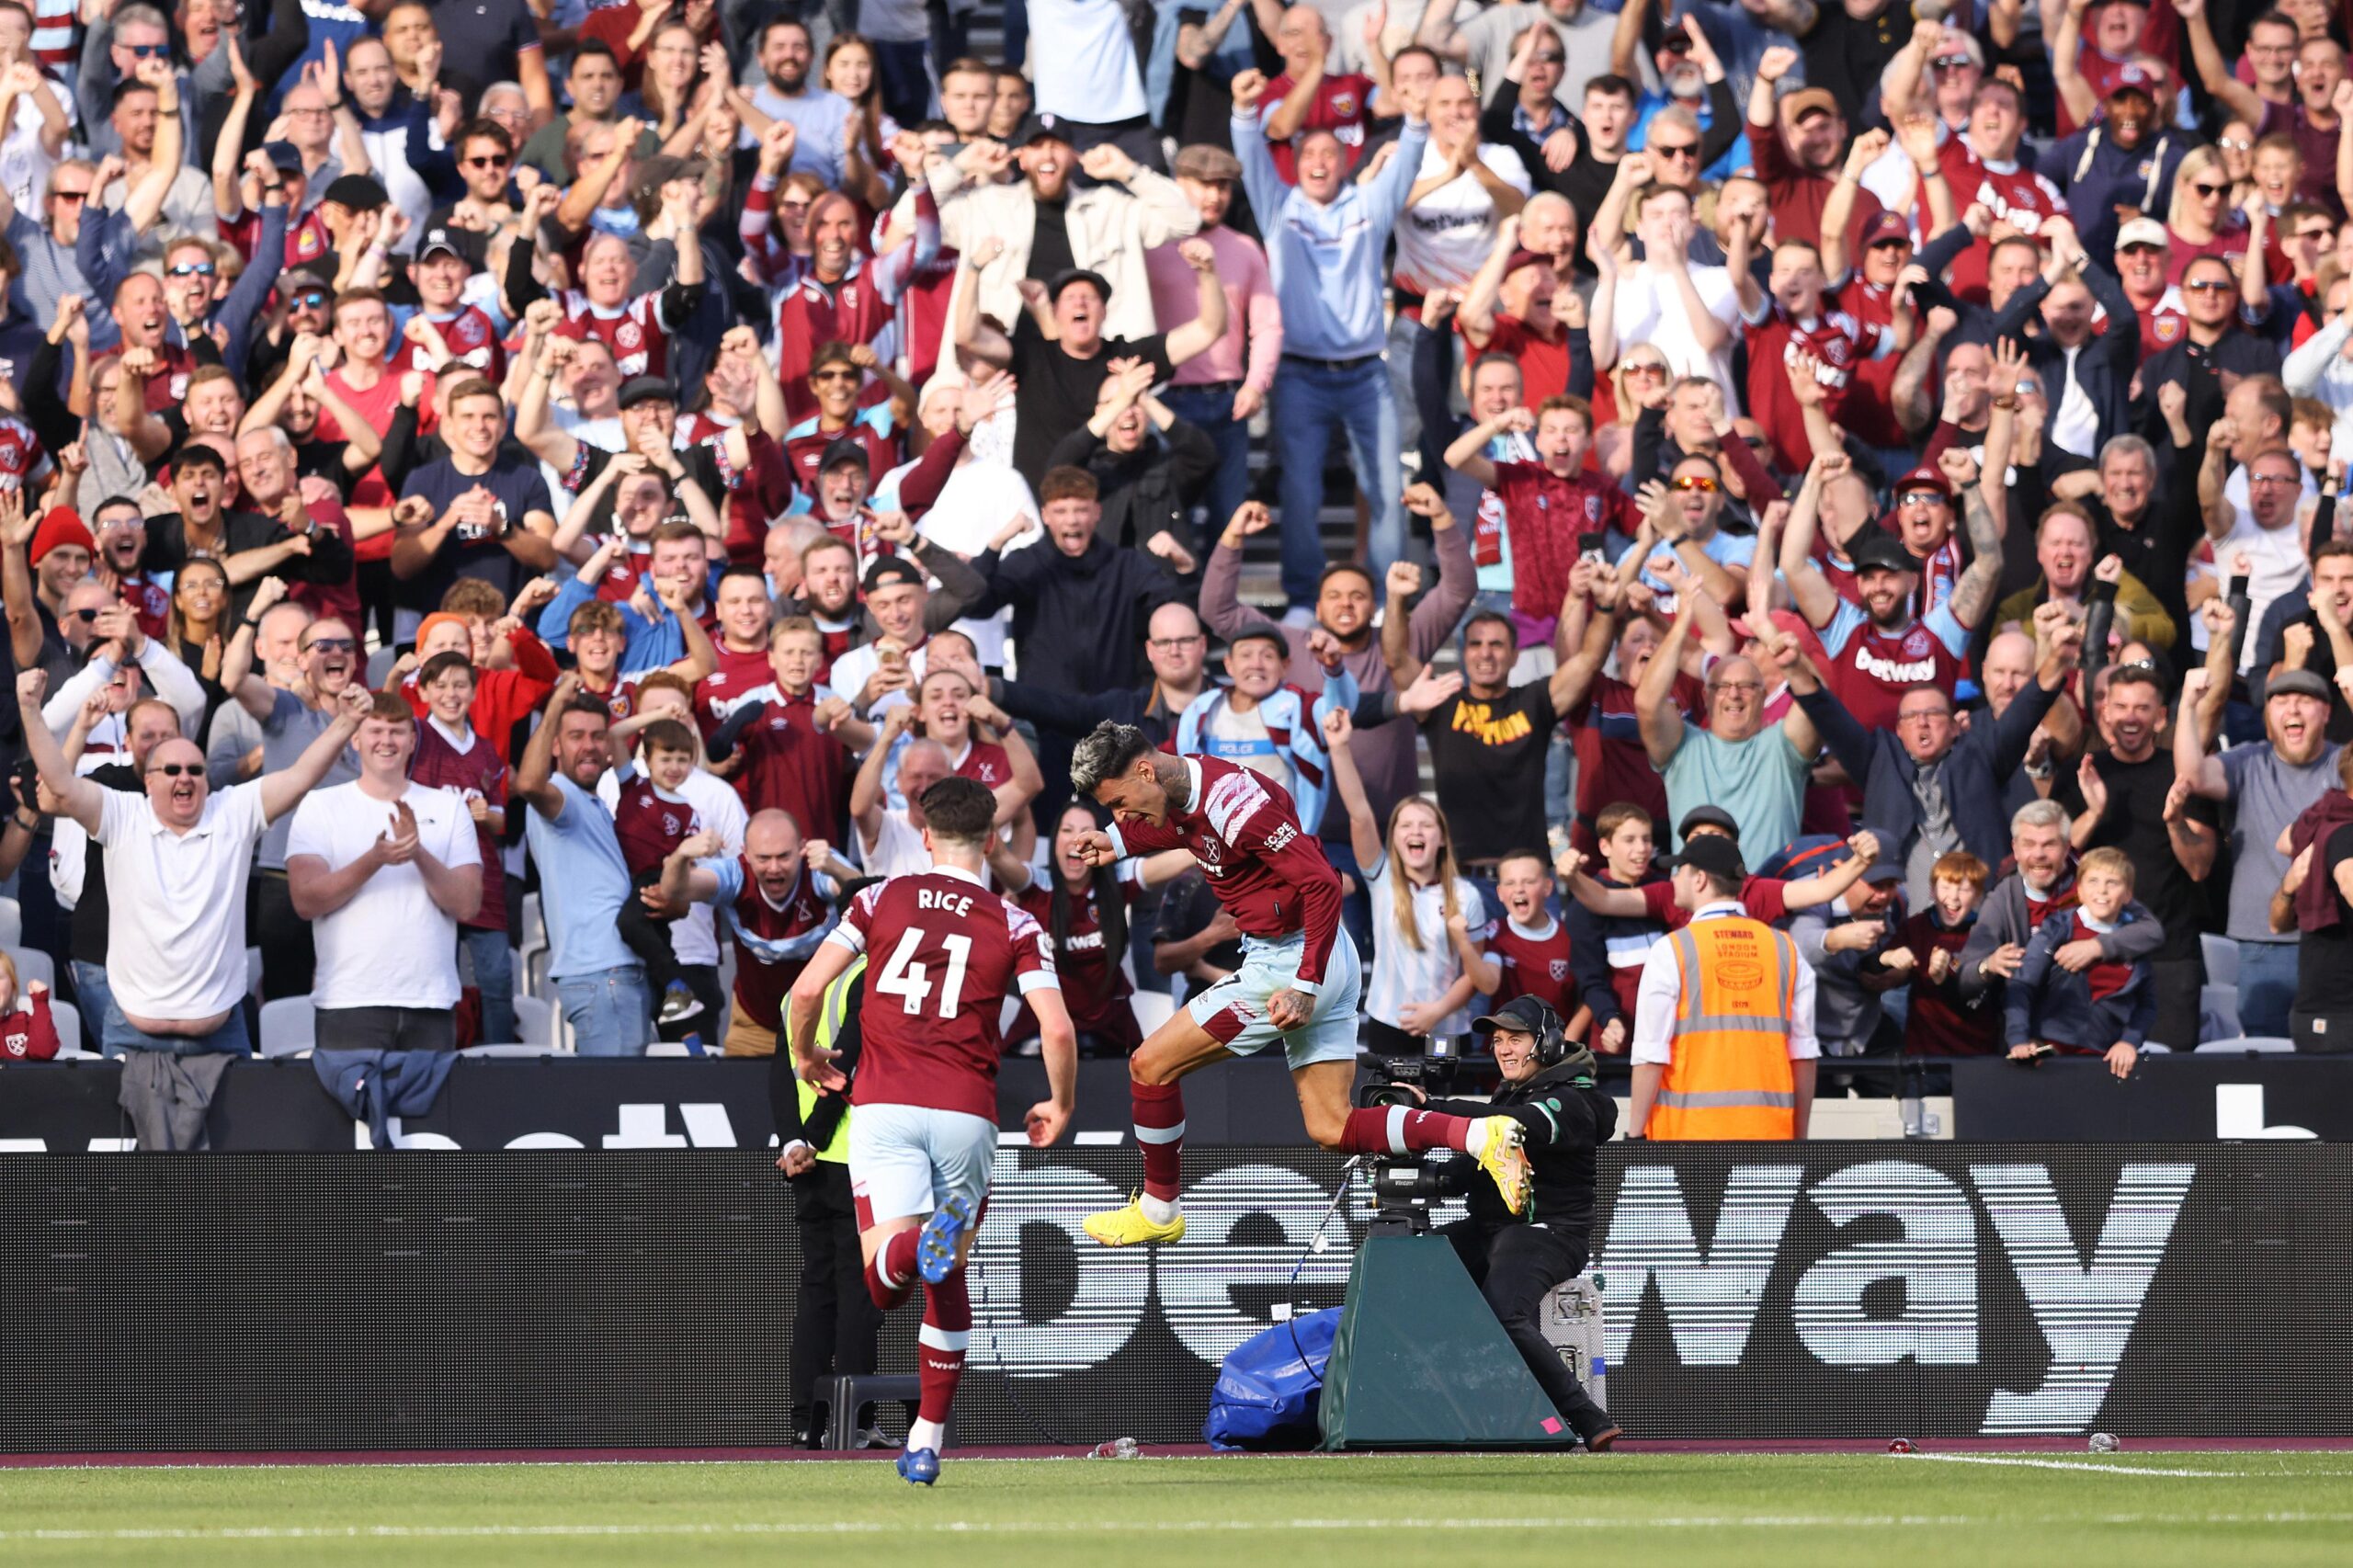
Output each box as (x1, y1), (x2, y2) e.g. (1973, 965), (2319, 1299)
(1593, 1165), (1805, 1366)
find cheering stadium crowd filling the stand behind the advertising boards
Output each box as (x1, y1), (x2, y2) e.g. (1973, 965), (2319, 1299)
(0, 0), (2353, 1076)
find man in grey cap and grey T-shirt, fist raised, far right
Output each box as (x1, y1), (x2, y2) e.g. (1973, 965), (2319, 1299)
(2174, 612), (2353, 1036)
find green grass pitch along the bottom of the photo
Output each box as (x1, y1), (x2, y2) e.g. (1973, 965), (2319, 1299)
(0, 1450), (2353, 1568)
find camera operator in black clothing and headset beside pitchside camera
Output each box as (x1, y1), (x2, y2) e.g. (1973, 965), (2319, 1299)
(1393, 996), (1619, 1452)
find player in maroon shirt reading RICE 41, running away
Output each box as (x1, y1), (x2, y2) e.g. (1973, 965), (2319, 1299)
(786, 777), (1077, 1485)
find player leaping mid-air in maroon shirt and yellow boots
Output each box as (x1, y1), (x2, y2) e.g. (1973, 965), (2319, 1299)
(1071, 721), (1527, 1248)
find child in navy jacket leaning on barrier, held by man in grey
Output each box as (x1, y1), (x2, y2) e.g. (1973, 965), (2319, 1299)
(2003, 847), (2158, 1078)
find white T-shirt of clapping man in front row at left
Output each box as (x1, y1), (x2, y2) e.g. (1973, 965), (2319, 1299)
(287, 779), (483, 1007)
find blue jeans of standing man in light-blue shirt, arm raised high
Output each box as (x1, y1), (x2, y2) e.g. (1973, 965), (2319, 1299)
(1273, 356), (1404, 608)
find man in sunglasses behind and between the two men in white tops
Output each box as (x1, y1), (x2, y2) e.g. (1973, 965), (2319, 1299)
(222, 577), (367, 1001)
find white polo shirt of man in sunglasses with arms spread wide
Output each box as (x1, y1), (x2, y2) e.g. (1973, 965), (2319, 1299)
(99, 784), (268, 1022)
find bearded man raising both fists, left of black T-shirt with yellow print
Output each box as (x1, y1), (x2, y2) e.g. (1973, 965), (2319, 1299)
(1213, 485), (1468, 828)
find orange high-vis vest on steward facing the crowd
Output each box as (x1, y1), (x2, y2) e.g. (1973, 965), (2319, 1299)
(1644, 915), (1802, 1140)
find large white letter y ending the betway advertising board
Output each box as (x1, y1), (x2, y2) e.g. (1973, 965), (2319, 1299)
(1970, 1163), (2195, 1437)
